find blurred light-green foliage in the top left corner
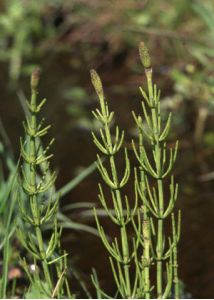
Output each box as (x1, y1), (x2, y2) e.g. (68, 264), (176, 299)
(0, 0), (58, 82)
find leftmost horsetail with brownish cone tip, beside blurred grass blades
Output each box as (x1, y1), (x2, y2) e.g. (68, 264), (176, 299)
(18, 69), (72, 298)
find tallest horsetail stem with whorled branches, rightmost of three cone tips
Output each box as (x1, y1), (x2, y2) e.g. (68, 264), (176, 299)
(134, 42), (180, 299)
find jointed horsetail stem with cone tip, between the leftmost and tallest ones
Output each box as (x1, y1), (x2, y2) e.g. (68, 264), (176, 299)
(91, 70), (133, 298)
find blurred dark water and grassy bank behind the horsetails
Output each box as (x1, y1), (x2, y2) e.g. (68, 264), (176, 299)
(0, 0), (214, 298)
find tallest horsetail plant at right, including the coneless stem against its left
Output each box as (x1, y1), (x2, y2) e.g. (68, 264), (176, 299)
(133, 42), (180, 299)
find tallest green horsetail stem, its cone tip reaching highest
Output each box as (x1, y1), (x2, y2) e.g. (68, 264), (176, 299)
(135, 42), (180, 298)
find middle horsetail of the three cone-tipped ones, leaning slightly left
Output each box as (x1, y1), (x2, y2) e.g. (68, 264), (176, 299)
(91, 70), (138, 298)
